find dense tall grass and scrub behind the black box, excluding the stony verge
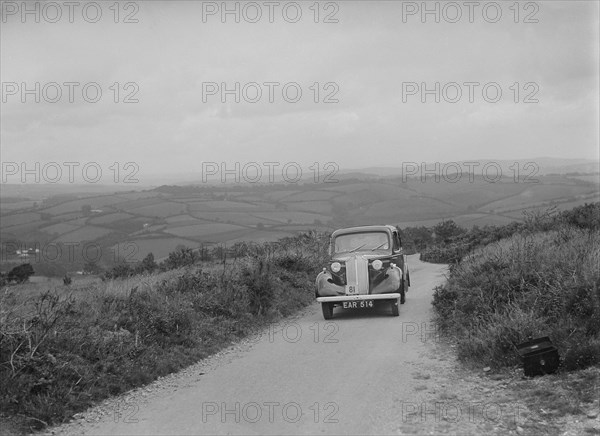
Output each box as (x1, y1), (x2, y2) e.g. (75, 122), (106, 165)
(433, 203), (600, 370)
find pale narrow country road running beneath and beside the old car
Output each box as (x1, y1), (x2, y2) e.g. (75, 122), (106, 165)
(48, 256), (524, 435)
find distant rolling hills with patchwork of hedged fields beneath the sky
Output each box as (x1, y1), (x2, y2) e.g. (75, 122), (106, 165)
(0, 166), (600, 268)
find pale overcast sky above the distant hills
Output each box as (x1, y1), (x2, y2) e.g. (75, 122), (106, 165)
(0, 1), (599, 182)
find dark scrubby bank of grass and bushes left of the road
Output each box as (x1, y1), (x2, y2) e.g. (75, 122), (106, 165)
(0, 232), (327, 428)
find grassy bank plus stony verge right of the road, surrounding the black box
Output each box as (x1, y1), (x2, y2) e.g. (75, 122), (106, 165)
(426, 204), (600, 435)
